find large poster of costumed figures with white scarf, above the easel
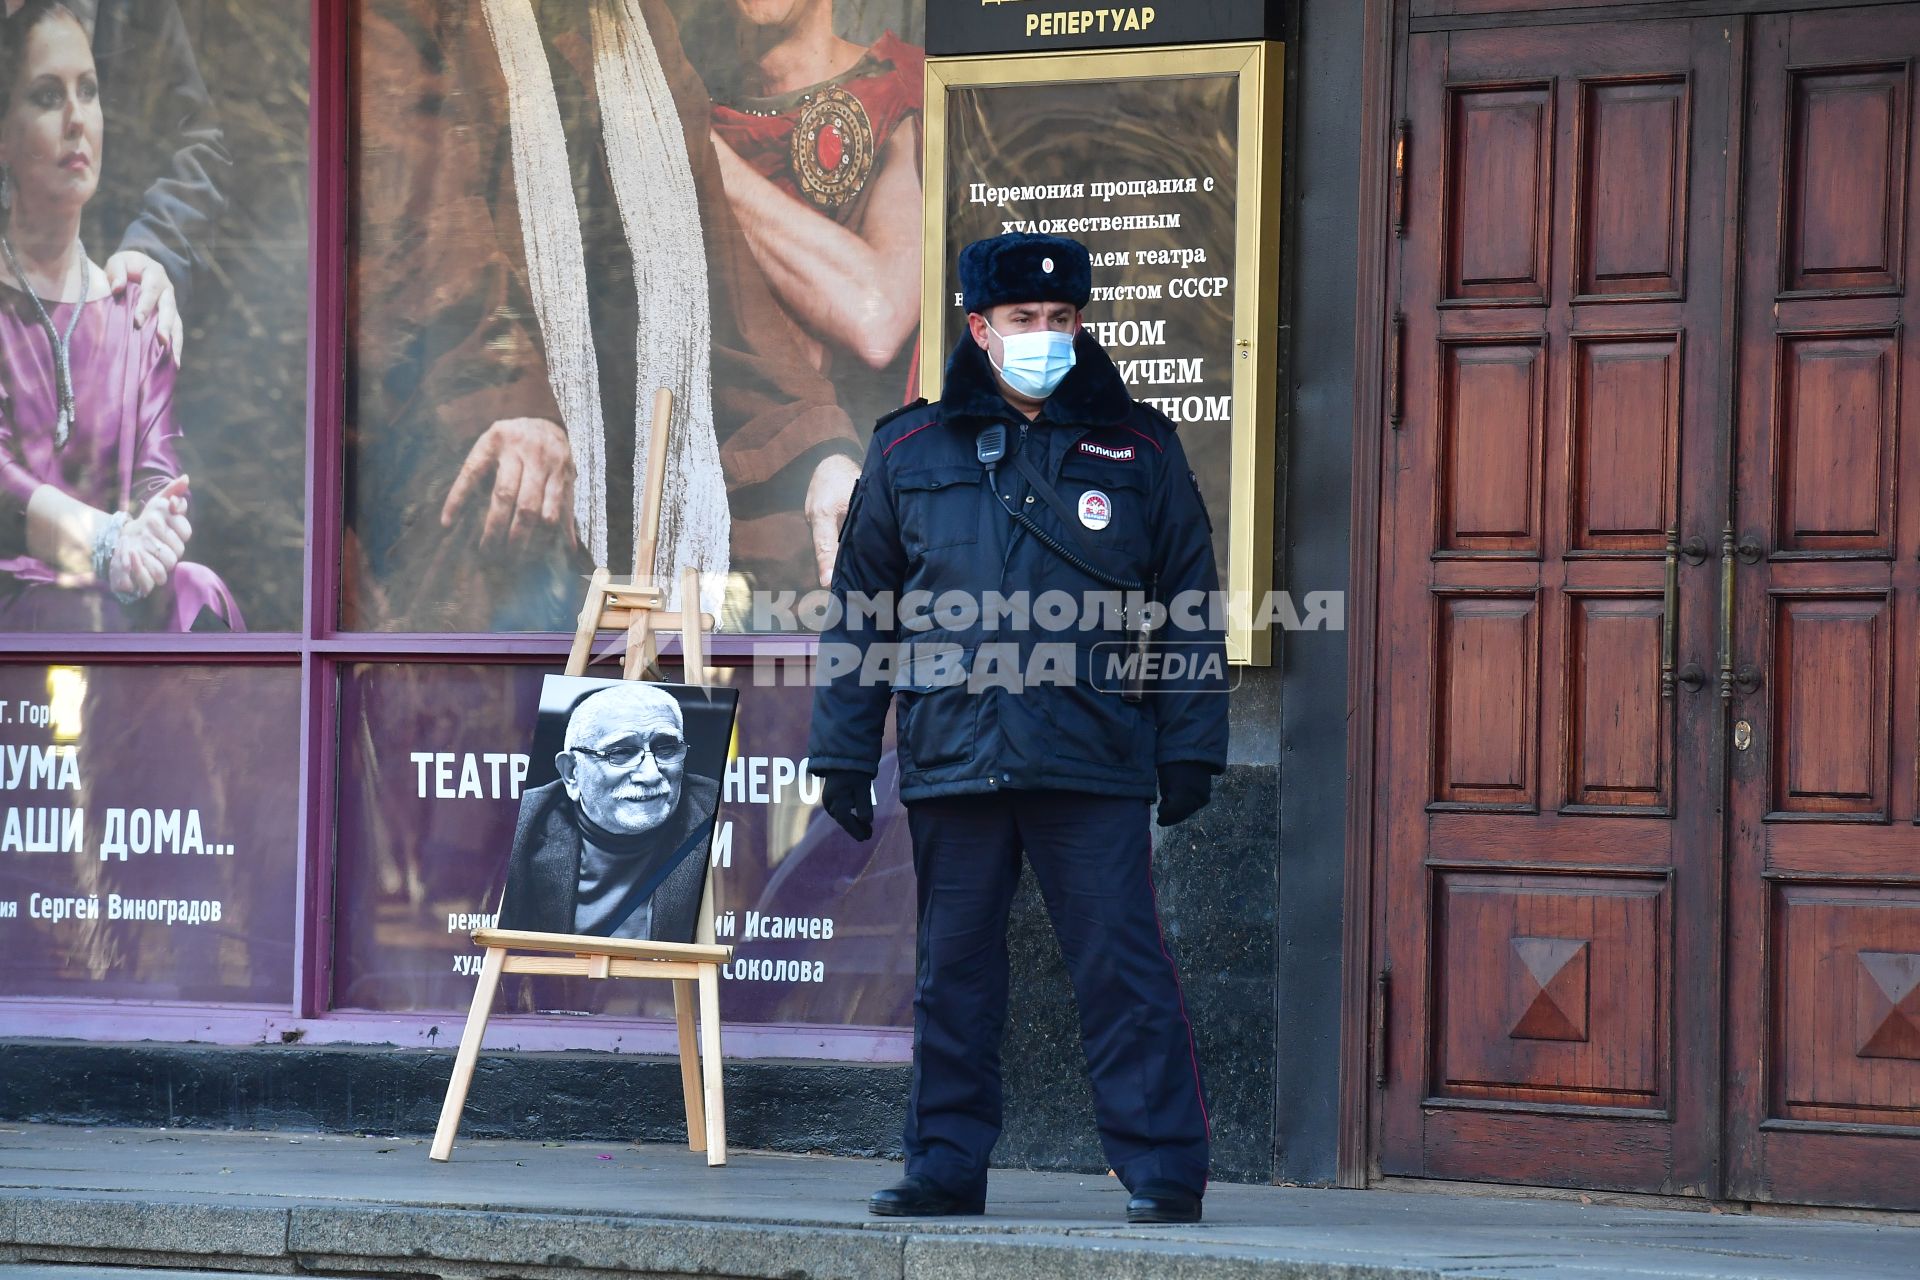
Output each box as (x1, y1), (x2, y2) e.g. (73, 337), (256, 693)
(340, 0), (925, 633)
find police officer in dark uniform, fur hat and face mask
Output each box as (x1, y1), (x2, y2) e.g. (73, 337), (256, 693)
(808, 234), (1227, 1222)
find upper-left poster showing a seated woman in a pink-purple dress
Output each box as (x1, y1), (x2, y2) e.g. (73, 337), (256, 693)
(0, 0), (309, 633)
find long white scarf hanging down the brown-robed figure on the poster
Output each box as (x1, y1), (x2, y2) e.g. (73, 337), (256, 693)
(482, 0), (732, 614)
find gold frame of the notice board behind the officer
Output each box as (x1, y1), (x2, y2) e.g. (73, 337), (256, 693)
(920, 40), (1286, 666)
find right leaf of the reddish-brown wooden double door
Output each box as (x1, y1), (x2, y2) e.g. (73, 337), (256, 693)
(1728, 4), (1920, 1207)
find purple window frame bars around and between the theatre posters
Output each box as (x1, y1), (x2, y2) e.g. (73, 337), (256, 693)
(0, 0), (912, 1063)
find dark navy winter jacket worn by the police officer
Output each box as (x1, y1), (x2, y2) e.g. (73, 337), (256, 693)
(808, 330), (1227, 800)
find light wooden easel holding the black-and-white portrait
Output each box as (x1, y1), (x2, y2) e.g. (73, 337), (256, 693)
(428, 388), (733, 1165)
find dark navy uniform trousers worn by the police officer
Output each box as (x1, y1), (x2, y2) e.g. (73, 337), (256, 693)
(904, 791), (1208, 1197)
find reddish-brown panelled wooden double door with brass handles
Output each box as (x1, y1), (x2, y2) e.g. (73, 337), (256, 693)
(1369, 0), (1920, 1209)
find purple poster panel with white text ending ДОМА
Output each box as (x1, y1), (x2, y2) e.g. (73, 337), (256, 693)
(0, 664), (300, 1009)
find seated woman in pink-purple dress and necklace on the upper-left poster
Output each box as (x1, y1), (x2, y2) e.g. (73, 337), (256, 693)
(0, 0), (244, 631)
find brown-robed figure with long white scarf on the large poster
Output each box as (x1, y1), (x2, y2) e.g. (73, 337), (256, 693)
(348, 0), (875, 629)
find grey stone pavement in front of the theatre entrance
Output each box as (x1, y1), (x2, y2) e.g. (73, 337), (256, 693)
(0, 1126), (1920, 1280)
